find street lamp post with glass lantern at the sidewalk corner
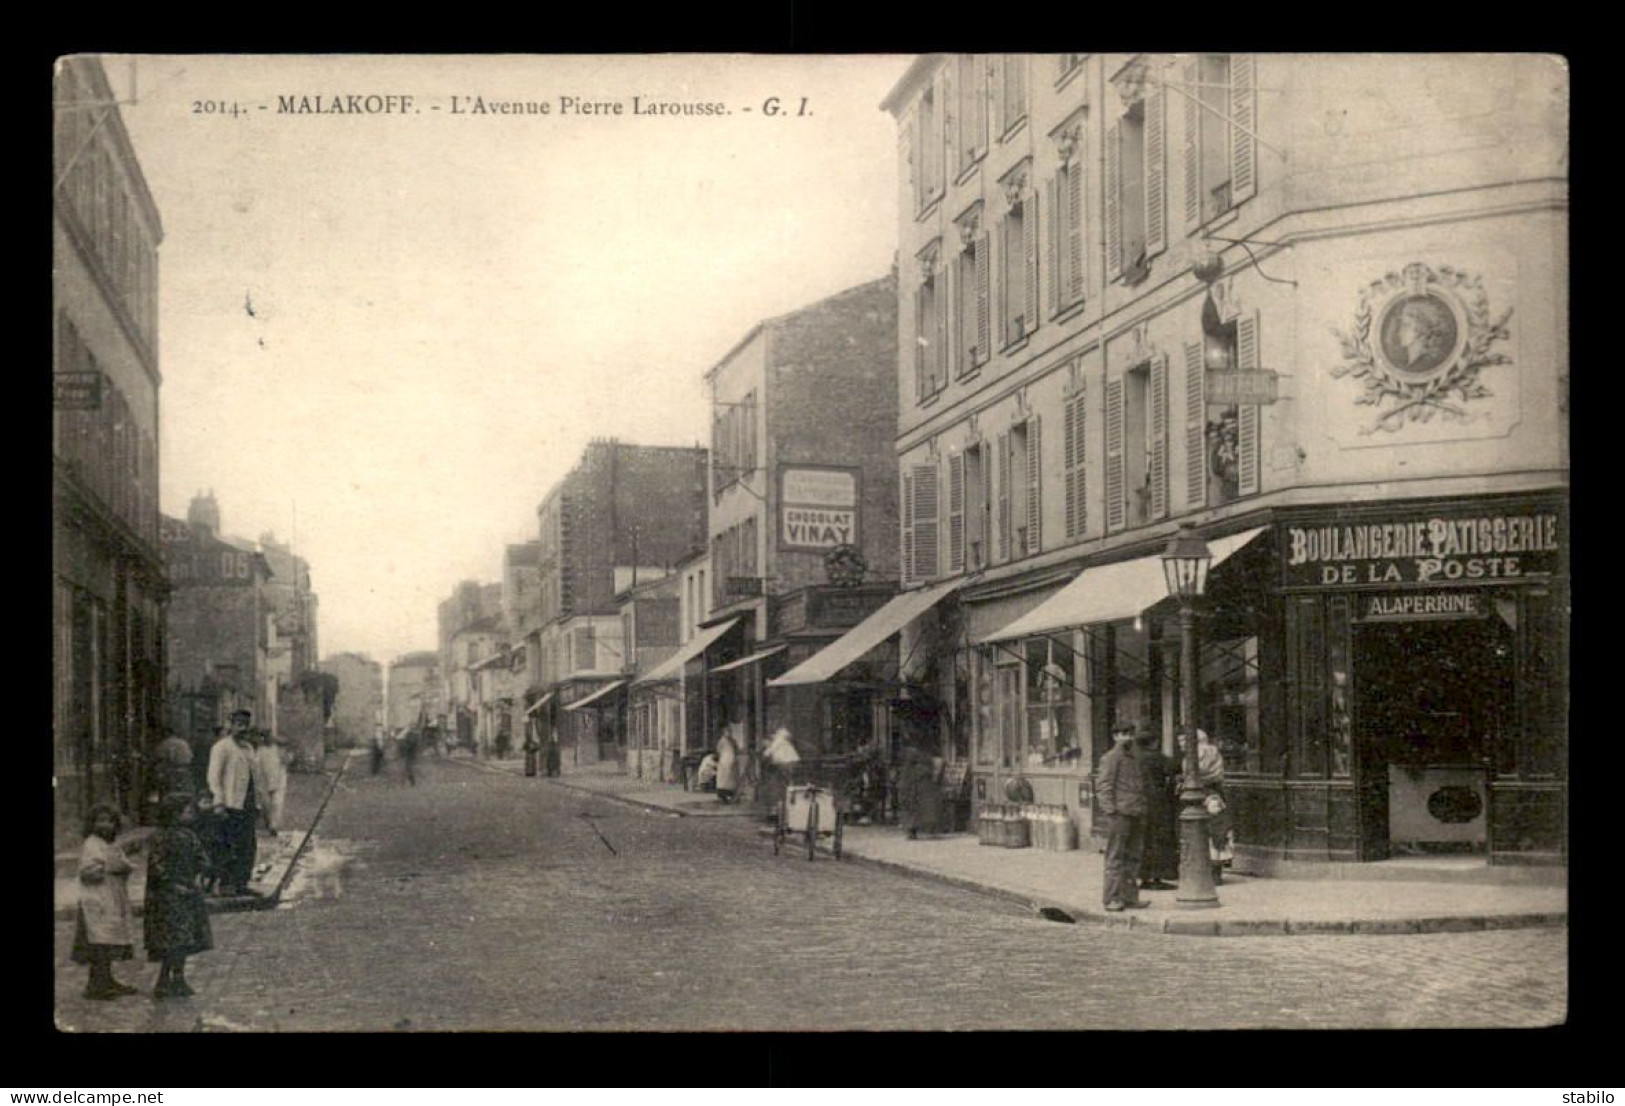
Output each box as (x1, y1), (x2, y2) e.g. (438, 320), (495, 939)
(1162, 523), (1219, 909)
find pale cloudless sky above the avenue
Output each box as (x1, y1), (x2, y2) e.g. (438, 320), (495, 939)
(104, 55), (910, 663)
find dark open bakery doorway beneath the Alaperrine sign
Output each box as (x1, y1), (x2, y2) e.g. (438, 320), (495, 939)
(1354, 617), (1515, 859)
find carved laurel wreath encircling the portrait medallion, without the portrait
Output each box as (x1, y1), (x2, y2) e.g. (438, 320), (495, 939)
(1331, 263), (1513, 434)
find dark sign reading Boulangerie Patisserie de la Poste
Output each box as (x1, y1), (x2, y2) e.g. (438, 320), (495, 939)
(1281, 507), (1567, 588)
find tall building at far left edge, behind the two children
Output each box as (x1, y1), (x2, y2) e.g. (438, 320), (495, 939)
(50, 57), (164, 830)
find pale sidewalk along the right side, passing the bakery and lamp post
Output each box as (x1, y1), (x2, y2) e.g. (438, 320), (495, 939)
(526, 762), (1568, 937)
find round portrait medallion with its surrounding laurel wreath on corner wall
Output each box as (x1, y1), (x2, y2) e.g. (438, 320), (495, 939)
(1331, 261), (1513, 434)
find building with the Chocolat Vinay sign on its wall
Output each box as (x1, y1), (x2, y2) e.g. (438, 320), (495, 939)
(702, 274), (897, 776)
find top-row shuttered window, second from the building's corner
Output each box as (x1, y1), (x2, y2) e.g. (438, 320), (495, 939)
(1107, 81), (1168, 281)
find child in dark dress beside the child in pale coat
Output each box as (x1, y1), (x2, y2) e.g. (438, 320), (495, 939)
(141, 794), (215, 999)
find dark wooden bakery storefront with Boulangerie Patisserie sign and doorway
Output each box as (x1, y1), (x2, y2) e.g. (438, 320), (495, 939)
(1235, 494), (1568, 862)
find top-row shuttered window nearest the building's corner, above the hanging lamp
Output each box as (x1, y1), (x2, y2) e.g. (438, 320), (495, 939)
(1183, 54), (1258, 227)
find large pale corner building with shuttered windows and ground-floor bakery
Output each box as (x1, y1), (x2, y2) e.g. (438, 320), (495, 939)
(882, 54), (1568, 871)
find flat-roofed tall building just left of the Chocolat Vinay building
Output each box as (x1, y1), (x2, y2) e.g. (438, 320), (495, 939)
(527, 439), (707, 762)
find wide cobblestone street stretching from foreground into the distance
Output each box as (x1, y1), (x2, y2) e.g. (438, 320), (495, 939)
(55, 760), (1567, 1031)
